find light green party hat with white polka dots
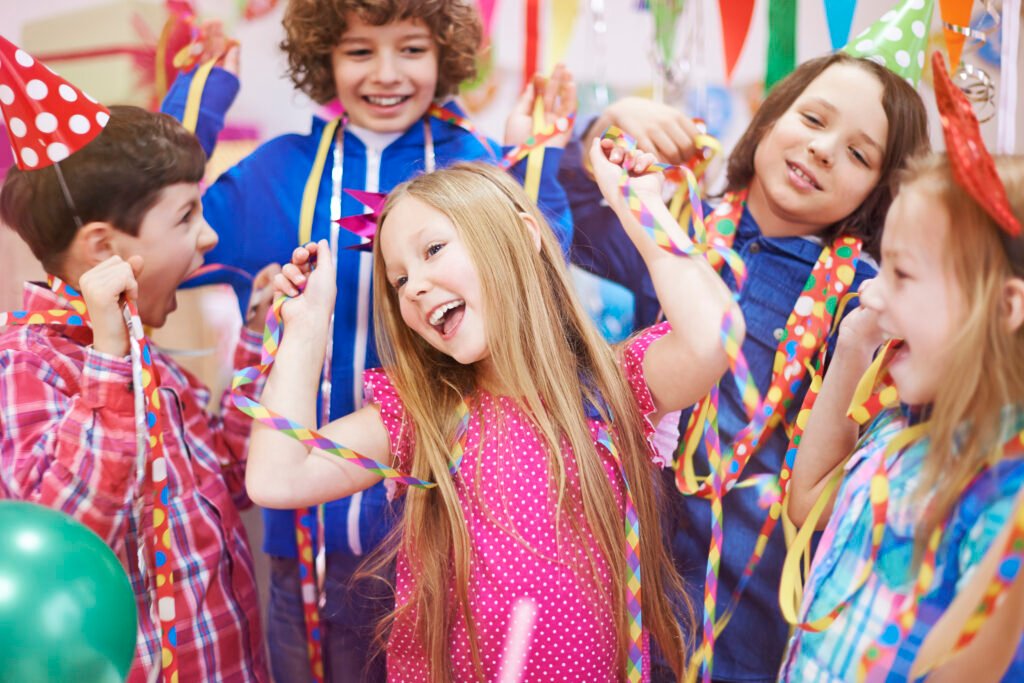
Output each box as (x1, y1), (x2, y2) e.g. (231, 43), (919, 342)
(843, 0), (935, 88)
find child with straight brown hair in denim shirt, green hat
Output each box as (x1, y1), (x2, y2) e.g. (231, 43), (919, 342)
(562, 52), (928, 682)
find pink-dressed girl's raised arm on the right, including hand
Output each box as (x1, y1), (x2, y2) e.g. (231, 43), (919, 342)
(590, 140), (745, 424)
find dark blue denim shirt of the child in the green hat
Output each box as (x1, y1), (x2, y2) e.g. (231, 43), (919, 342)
(559, 136), (876, 682)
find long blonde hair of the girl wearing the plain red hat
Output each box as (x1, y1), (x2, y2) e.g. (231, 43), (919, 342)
(901, 155), (1024, 557)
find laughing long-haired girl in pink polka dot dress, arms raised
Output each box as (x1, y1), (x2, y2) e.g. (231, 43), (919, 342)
(247, 145), (742, 680)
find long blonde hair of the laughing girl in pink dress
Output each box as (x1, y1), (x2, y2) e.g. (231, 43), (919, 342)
(364, 164), (692, 681)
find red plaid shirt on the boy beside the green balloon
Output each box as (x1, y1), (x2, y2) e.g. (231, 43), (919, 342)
(0, 284), (269, 683)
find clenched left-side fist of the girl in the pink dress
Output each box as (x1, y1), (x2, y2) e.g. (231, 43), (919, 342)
(273, 240), (338, 330)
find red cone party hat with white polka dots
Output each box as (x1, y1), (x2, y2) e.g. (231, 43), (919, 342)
(0, 36), (111, 171)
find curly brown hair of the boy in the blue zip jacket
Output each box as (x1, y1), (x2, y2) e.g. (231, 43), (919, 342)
(281, 0), (483, 104)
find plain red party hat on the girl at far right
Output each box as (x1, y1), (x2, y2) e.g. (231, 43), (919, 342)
(932, 52), (1021, 237)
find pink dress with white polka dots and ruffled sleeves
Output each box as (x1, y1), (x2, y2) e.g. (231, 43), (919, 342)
(365, 324), (670, 682)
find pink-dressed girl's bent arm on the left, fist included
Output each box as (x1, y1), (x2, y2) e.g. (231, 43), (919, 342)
(246, 241), (390, 508)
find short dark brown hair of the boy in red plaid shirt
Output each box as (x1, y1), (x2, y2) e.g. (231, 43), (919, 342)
(0, 106), (206, 273)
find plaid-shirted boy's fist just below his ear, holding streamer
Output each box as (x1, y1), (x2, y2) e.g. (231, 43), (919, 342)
(78, 256), (142, 357)
